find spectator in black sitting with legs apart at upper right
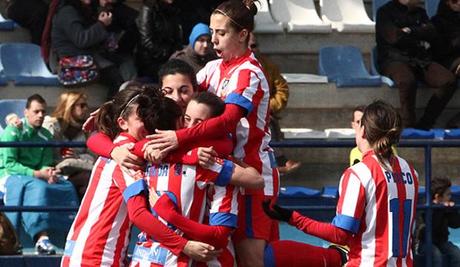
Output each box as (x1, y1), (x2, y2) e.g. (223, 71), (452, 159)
(376, 0), (455, 129)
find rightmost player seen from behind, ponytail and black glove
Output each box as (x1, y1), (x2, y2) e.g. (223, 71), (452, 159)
(264, 101), (418, 267)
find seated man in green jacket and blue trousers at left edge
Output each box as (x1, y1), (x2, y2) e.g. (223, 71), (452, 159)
(0, 94), (78, 255)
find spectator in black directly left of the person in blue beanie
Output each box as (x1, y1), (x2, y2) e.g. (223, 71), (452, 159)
(136, 0), (182, 82)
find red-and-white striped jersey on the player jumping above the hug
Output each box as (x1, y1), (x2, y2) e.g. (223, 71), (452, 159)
(197, 50), (279, 196)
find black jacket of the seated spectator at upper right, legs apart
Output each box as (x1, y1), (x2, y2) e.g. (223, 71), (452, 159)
(375, 0), (436, 67)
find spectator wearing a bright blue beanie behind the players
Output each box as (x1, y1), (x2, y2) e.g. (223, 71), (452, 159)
(171, 23), (217, 73)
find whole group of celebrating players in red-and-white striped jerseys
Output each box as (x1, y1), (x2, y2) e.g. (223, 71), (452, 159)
(61, 0), (424, 267)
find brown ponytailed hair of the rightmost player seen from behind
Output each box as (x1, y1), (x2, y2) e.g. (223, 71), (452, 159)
(361, 100), (402, 167)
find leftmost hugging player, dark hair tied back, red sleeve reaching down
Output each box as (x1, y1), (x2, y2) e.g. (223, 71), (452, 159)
(61, 88), (216, 266)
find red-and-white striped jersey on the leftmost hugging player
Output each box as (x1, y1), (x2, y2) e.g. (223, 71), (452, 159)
(61, 134), (136, 266)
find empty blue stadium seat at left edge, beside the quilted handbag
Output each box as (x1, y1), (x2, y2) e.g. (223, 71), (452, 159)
(0, 43), (59, 86)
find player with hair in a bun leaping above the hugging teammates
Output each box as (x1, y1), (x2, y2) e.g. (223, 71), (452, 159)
(146, 0), (278, 267)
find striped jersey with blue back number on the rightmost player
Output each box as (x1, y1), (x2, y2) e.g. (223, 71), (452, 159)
(332, 151), (418, 267)
